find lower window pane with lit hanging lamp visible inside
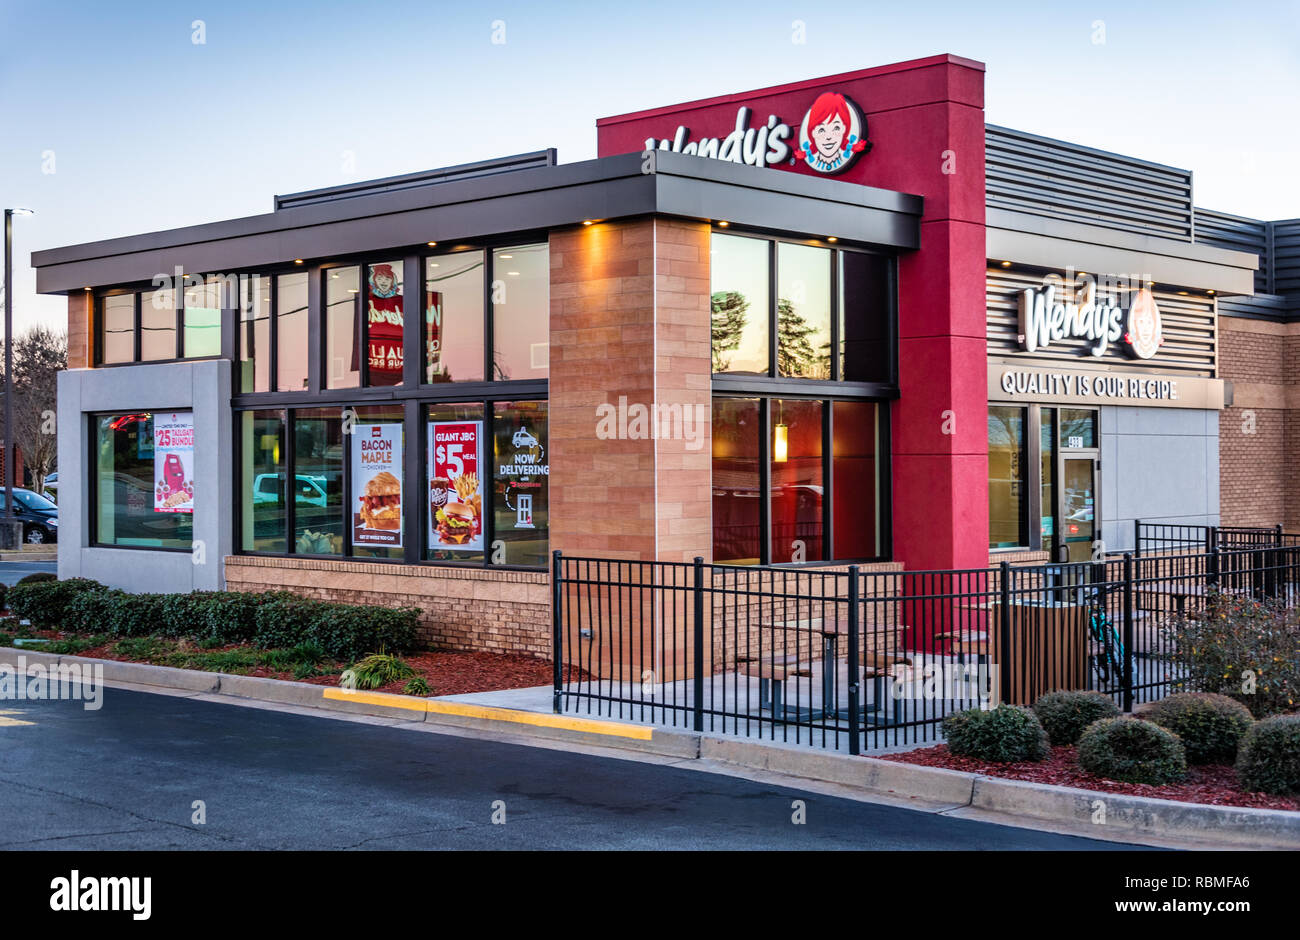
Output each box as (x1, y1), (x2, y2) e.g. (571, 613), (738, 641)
(770, 398), (826, 564)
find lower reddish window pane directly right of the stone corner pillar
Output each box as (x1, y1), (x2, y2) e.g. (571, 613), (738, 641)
(712, 398), (763, 564)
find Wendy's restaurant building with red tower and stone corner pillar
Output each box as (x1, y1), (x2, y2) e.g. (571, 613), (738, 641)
(33, 49), (1300, 654)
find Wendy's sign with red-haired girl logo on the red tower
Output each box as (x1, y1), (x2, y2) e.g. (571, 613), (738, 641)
(645, 91), (871, 174)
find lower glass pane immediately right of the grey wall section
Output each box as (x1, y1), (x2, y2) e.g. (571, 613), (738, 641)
(239, 411), (288, 553)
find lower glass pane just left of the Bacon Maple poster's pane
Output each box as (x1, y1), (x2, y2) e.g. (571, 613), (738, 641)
(293, 407), (346, 555)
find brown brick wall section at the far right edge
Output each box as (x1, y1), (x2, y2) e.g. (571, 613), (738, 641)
(1219, 317), (1300, 532)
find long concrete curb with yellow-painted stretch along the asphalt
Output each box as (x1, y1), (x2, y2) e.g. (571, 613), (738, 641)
(0, 647), (1300, 849)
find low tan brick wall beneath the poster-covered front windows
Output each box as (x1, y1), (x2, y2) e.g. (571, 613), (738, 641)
(225, 555), (551, 658)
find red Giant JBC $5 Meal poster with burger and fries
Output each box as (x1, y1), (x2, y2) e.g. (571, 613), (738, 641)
(429, 421), (484, 551)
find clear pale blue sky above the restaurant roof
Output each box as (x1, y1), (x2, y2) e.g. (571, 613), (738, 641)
(0, 0), (1300, 330)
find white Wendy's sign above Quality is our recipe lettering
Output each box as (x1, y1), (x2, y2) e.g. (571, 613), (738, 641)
(1021, 276), (1165, 359)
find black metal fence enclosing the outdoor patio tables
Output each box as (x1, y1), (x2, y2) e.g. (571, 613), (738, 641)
(553, 532), (1300, 754)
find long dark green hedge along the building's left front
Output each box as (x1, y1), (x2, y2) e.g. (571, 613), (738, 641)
(9, 579), (419, 662)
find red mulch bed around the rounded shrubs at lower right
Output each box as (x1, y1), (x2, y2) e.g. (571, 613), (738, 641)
(879, 744), (1300, 810)
